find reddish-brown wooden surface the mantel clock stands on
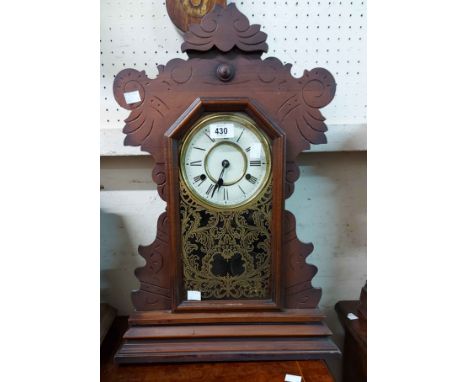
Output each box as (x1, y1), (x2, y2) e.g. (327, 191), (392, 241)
(101, 317), (334, 382)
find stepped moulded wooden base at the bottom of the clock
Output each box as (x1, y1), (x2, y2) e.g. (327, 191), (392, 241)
(115, 309), (340, 364)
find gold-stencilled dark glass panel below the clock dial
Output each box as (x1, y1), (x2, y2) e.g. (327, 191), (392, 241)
(180, 181), (271, 300)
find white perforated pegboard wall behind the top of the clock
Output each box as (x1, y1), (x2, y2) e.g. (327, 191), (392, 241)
(101, 0), (367, 155)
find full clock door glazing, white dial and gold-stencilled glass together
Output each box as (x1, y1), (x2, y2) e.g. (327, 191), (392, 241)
(180, 113), (272, 300)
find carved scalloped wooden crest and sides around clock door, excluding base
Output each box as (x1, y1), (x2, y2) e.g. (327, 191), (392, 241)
(114, 3), (336, 310)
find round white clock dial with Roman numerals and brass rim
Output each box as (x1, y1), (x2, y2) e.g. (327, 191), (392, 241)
(180, 114), (271, 209)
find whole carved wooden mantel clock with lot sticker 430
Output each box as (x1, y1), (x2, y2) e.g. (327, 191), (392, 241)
(114, 4), (339, 363)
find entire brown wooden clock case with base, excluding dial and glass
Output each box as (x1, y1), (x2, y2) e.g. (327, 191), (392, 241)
(114, 4), (339, 363)
